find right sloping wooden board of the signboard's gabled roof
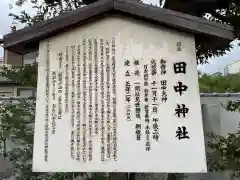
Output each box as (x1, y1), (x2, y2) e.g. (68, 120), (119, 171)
(114, 0), (234, 39)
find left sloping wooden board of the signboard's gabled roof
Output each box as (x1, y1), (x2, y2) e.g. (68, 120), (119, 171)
(3, 0), (113, 49)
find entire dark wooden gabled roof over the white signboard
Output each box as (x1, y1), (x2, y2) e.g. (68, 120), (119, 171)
(3, 0), (234, 54)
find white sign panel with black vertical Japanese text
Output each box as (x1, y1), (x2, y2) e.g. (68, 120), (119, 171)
(33, 18), (206, 172)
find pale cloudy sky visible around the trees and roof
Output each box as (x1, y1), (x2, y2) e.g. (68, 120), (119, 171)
(0, 0), (240, 74)
